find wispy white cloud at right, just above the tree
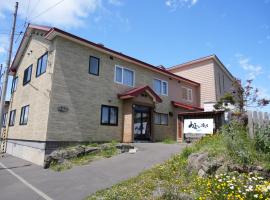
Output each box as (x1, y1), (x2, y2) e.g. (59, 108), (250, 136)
(235, 54), (263, 79)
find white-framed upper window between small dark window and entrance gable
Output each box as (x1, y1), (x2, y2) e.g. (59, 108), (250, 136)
(114, 66), (134, 87)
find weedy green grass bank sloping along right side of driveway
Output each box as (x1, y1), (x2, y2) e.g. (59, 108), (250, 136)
(87, 124), (270, 200)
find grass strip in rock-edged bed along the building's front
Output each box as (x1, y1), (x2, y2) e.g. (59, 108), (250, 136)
(50, 141), (119, 171)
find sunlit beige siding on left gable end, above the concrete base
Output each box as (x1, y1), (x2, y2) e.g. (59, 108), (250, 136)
(7, 31), (54, 141)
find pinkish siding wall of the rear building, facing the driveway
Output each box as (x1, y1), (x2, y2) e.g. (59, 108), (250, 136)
(171, 61), (217, 107)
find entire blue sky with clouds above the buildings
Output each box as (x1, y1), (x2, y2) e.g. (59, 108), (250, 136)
(0, 0), (270, 111)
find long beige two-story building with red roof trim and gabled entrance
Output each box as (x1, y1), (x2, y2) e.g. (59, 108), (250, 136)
(0, 25), (202, 165)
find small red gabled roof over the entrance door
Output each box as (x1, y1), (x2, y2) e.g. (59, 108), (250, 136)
(118, 85), (162, 103)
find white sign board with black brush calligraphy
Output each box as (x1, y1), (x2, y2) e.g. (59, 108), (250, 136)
(184, 119), (214, 134)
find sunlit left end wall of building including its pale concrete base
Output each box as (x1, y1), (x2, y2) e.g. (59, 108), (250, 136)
(4, 29), (54, 164)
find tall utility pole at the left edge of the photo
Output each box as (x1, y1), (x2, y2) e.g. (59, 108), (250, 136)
(0, 2), (19, 133)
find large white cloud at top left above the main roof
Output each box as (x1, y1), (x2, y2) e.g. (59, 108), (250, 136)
(0, 0), (121, 28)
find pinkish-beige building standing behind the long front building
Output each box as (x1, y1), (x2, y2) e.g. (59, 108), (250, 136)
(168, 55), (236, 110)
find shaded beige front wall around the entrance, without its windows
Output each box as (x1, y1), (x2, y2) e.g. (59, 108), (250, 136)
(48, 38), (199, 141)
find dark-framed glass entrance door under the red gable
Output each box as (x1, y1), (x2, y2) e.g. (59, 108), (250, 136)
(133, 105), (151, 140)
